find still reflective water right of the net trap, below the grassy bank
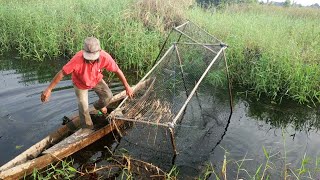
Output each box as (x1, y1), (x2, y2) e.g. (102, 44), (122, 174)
(210, 98), (320, 179)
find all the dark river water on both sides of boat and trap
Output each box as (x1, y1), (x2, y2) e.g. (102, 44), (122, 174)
(0, 57), (320, 177)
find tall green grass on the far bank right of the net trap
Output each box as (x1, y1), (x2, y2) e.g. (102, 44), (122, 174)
(187, 5), (320, 103)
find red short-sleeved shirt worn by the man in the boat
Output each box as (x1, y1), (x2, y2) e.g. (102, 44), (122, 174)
(62, 50), (119, 89)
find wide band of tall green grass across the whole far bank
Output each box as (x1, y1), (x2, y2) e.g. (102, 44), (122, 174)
(0, 0), (320, 103)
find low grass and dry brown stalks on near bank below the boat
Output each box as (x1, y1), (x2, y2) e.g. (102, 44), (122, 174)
(24, 154), (178, 180)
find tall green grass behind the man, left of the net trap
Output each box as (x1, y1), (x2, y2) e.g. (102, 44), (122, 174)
(0, 0), (162, 74)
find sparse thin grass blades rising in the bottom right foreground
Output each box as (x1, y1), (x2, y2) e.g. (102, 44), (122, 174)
(198, 142), (320, 180)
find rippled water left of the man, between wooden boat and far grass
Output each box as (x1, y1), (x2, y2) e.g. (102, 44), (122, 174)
(0, 57), (85, 164)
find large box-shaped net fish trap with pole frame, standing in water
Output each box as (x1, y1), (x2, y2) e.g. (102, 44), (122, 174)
(112, 22), (232, 174)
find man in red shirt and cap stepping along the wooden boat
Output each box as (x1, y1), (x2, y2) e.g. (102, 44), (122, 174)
(41, 37), (133, 129)
